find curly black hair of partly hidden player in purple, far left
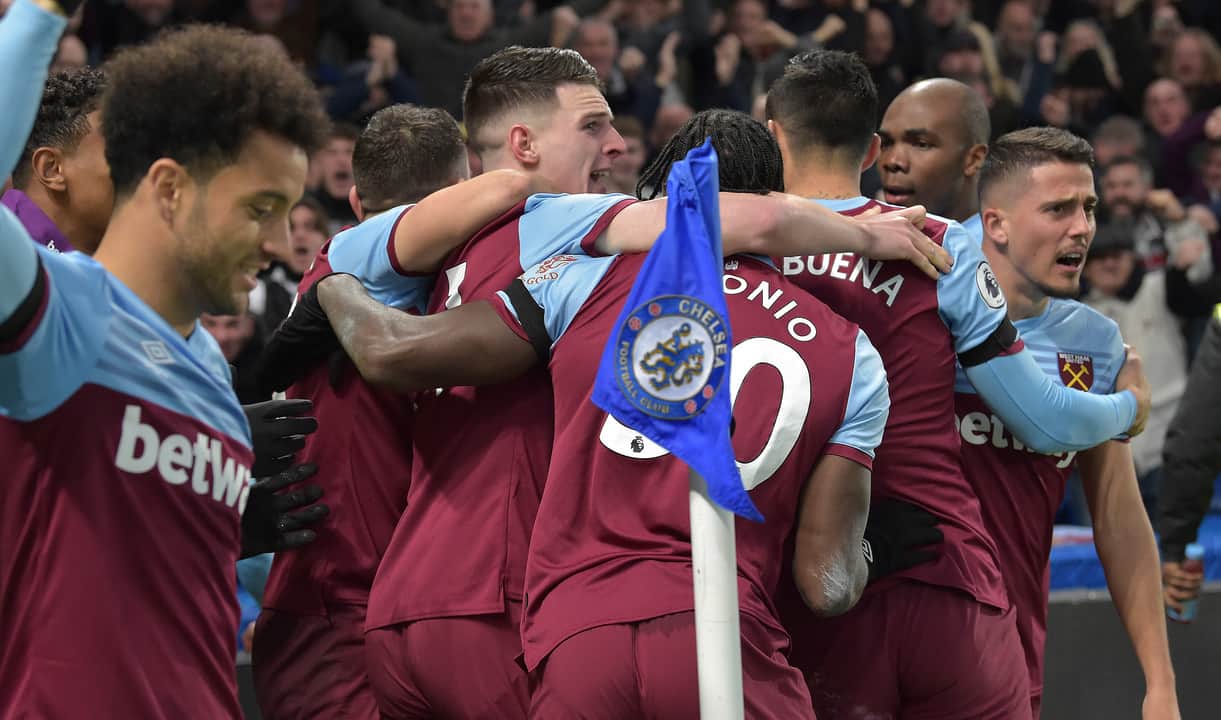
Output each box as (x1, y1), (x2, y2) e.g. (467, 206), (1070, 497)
(12, 67), (106, 189)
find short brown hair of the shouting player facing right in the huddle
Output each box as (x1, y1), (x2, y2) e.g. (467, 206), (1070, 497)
(462, 45), (602, 153)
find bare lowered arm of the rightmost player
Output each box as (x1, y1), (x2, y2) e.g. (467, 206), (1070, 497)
(1078, 442), (1178, 718)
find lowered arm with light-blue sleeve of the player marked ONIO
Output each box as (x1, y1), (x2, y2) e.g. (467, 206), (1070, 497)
(792, 331), (890, 616)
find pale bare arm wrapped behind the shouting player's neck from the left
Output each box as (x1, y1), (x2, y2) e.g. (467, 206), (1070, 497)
(394, 170), (531, 272)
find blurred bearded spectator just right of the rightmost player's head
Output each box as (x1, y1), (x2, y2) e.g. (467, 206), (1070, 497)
(1103, 156), (1212, 283)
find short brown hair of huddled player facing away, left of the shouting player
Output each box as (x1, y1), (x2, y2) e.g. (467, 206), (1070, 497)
(352, 104), (466, 212)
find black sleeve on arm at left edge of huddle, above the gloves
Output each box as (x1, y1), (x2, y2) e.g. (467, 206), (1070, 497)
(255, 273), (354, 393)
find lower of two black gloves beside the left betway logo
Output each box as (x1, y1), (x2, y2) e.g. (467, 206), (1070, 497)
(242, 463), (331, 558)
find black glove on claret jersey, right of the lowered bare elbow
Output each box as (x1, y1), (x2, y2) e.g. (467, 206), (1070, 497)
(861, 498), (945, 582)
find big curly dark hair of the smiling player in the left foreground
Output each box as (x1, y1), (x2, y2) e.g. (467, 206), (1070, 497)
(101, 24), (328, 195)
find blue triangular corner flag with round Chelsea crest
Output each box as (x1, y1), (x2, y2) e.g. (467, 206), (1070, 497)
(593, 140), (763, 521)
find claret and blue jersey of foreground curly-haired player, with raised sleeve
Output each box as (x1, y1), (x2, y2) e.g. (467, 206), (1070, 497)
(0, 1), (253, 718)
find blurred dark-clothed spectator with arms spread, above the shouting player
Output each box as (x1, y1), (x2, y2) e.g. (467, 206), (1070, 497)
(346, 0), (607, 117)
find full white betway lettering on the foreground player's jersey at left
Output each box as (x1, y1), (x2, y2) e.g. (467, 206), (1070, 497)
(115, 405), (250, 515)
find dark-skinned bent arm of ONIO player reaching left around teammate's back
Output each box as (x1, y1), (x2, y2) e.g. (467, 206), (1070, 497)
(317, 275), (538, 392)
